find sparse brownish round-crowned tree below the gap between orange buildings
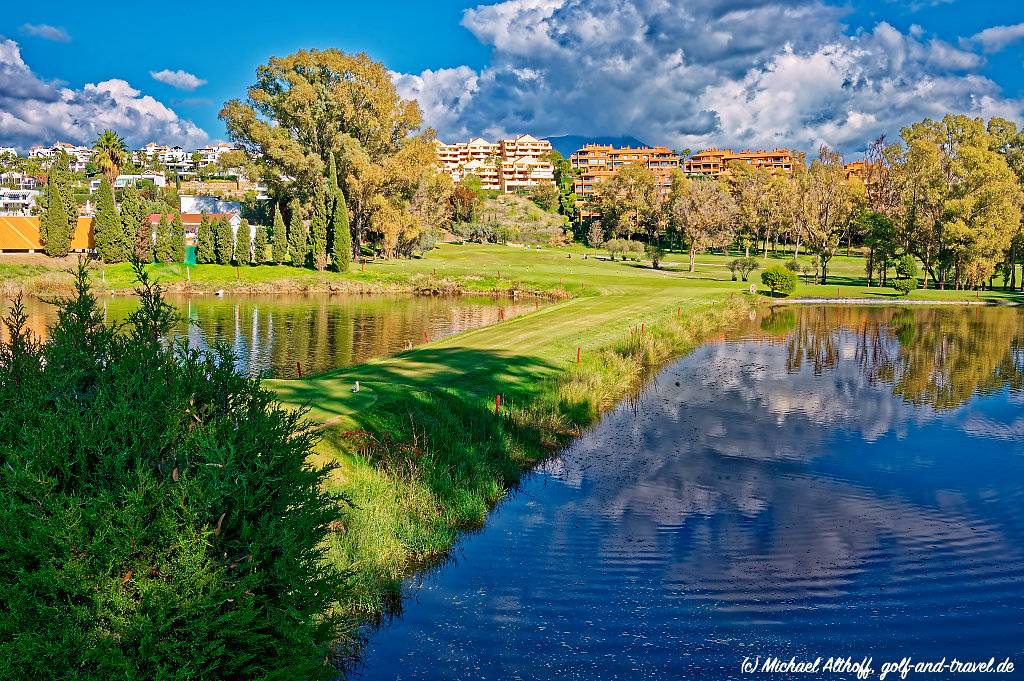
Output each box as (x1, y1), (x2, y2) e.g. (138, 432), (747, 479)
(669, 175), (739, 272)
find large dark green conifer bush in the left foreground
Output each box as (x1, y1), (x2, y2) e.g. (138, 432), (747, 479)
(0, 264), (343, 679)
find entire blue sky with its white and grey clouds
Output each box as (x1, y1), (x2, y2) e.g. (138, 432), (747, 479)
(0, 0), (1024, 152)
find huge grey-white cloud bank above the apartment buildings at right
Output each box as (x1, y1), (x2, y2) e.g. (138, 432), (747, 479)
(395, 0), (1024, 152)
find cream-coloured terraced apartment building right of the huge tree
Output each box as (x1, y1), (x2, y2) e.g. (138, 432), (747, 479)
(437, 135), (555, 194)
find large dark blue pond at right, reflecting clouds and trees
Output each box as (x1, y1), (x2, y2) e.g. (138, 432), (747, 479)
(352, 307), (1024, 679)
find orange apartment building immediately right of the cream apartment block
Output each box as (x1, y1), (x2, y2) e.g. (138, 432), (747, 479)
(569, 144), (679, 203)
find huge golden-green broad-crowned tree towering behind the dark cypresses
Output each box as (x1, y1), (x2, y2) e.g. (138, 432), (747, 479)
(220, 49), (438, 254)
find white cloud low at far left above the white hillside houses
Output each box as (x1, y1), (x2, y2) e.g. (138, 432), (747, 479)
(0, 38), (208, 150)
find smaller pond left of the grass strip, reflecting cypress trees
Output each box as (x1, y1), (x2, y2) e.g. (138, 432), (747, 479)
(0, 295), (539, 378)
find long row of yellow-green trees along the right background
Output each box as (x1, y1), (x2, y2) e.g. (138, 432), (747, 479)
(587, 115), (1024, 289)
